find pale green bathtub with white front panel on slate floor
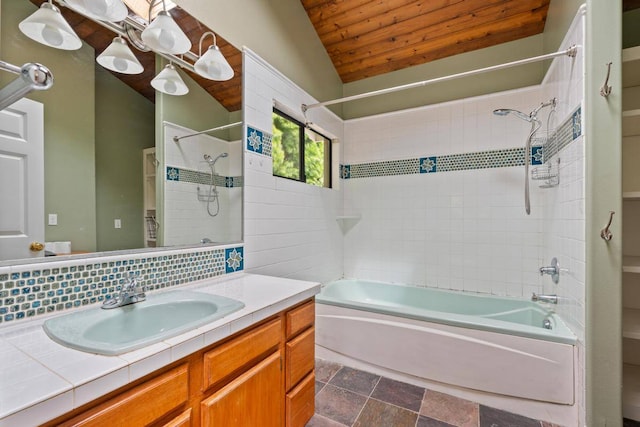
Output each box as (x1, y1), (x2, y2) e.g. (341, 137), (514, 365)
(316, 280), (576, 408)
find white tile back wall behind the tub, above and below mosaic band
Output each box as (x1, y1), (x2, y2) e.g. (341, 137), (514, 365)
(343, 87), (544, 297)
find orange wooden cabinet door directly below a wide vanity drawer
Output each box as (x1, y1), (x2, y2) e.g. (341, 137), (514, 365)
(201, 351), (284, 427)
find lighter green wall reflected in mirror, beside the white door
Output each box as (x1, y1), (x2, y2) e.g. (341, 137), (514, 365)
(0, 0), (96, 251)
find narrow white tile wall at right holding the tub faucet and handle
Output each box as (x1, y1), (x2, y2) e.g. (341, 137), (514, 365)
(542, 6), (586, 426)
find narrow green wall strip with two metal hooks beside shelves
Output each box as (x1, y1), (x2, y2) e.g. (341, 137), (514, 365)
(584, 0), (624, 427)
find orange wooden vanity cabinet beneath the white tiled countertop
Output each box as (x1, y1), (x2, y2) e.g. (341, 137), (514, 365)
(44, 300), (315, 427)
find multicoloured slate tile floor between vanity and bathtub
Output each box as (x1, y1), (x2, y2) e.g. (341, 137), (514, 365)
(307, 359), (558, 427)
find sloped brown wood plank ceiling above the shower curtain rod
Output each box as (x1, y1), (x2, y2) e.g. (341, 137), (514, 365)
(301, 0), (640, 83)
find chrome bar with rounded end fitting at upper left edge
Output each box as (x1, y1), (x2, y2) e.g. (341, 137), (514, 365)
(0, 61), (53, 111)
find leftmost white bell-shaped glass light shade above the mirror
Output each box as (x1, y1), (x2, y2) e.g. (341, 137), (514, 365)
(18, 3), (82, 50)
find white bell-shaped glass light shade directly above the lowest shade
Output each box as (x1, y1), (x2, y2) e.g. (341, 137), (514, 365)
(142, 10), (191, 55)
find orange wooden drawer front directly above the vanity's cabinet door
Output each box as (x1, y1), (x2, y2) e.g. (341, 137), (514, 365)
(203, 319), (282, 390)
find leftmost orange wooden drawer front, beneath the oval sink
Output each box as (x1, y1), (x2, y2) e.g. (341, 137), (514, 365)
(62, 364), (189, 427)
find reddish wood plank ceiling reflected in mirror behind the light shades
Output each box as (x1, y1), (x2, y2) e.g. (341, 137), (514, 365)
(31, 0), (242, 111)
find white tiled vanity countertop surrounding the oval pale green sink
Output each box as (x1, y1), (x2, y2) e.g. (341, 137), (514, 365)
(0, 273), (320, 427)
